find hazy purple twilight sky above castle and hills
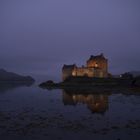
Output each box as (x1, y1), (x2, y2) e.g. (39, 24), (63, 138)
(0, 0), (140, 79)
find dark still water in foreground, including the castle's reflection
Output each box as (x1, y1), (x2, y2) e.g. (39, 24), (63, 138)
(0, 85), (140, 140)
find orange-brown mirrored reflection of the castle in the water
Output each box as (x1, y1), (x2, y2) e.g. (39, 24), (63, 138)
(63, 90), (109, 114)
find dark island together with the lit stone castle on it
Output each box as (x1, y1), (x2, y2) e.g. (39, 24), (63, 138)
(39, 53), (140, 89)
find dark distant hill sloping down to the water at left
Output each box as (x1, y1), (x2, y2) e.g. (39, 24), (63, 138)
(0, 69), (35, 82)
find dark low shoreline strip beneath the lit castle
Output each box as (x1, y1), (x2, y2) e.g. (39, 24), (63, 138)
(39, 76), (140, 90)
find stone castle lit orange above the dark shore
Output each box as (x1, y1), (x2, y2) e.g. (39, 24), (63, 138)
(62, 53), (108, 80)
